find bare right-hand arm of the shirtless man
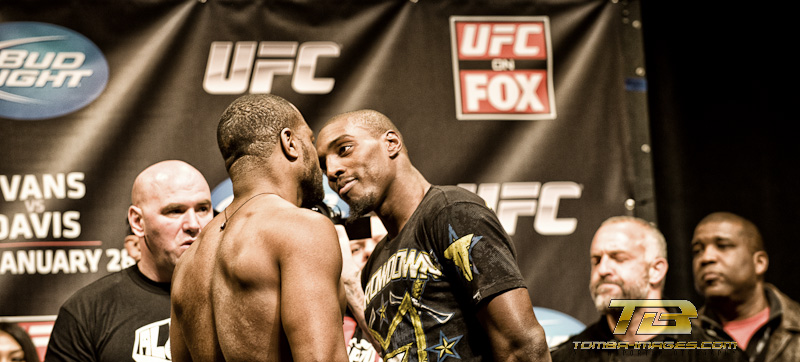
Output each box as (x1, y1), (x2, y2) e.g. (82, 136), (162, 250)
(279, 210), (347, 361)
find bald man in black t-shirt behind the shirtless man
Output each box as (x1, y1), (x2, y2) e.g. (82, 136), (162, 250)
(45, 160), (213, 362)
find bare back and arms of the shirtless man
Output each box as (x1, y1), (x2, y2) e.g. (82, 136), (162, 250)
(170, 194), (346, 361)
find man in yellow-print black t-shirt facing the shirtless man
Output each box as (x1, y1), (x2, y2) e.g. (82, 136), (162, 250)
(317, 110), (550, 362)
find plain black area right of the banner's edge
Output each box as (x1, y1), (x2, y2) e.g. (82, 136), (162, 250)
(642, 1), (800, 303)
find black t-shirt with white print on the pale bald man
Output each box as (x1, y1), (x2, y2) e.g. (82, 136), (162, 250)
(45, 265), (171, 362)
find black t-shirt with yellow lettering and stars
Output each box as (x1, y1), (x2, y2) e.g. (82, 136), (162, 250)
(362, 186), (525, 362)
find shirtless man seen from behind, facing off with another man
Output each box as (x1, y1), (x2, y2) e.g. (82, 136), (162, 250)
(170, 94), (347, 361)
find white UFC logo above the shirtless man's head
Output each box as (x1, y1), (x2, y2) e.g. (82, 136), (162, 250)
(203, 41), (341, 94)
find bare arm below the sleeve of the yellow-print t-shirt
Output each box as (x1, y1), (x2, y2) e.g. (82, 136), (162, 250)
(478, 288), (550, 361)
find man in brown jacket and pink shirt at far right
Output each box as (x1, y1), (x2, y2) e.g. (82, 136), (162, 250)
(692, 212), (800, 362)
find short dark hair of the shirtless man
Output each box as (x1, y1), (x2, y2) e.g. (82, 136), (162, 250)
(217, 94), (301, 171)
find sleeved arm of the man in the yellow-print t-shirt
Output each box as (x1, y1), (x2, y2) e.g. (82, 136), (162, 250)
(436, 202), (550, 361)
